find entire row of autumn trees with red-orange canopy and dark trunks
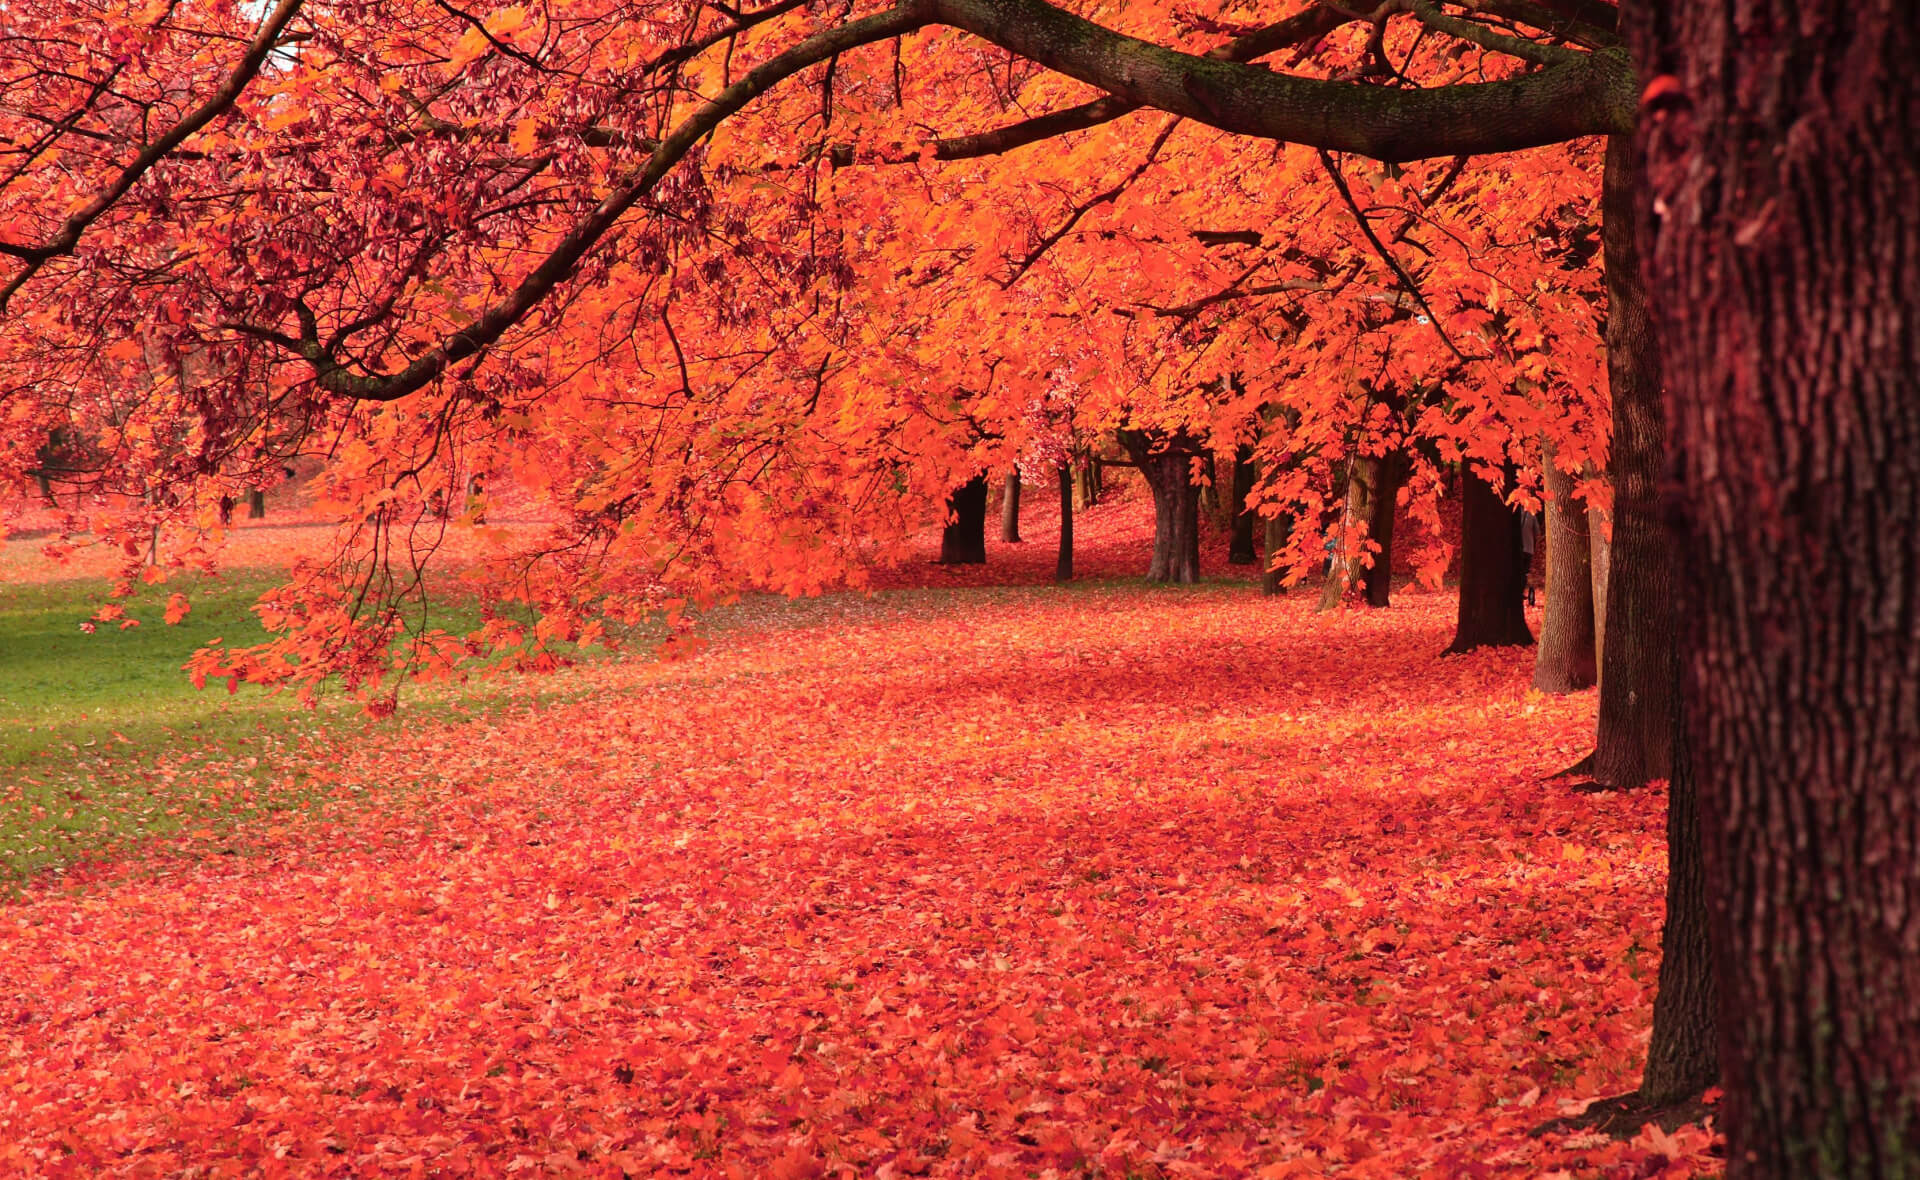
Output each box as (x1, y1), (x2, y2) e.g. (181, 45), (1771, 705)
(0, 0), (1920, 1178)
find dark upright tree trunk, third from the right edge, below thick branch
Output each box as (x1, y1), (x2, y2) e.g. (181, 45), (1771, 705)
(1584, 136), (1676, 789)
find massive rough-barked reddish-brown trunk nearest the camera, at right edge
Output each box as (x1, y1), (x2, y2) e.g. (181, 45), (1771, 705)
(1617, 0), (1920, 1180)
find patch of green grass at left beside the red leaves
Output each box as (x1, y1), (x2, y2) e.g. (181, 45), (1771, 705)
(0, 570), (568, 888)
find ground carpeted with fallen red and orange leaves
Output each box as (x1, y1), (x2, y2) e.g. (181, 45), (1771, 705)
(0, 585), (1711, 1178)
